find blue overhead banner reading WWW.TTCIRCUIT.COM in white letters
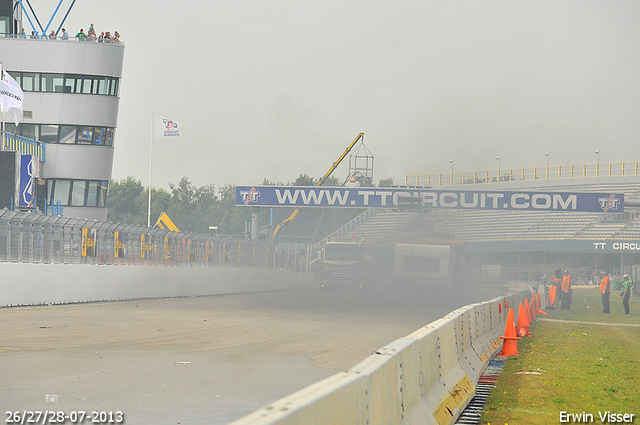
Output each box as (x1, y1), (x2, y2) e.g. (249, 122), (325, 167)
(236, 186), (624, 212)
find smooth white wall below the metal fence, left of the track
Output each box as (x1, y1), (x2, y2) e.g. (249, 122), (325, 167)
(0, 263), (313, 307)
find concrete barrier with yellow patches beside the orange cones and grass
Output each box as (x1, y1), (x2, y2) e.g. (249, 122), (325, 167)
(232, 293), (524, 425)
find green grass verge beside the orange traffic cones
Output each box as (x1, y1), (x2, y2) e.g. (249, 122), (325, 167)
(481, 287), (640, 425)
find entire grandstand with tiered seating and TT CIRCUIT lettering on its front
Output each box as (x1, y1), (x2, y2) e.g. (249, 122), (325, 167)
(324, 171), (640, 276)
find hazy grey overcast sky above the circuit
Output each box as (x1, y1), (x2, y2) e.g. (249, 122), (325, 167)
(32, 0), (640, 188)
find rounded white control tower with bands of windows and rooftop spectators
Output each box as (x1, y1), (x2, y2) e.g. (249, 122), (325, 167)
(0, 0), (124, 221)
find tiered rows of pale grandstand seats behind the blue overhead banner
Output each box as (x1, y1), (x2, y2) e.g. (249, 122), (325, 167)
(336, 177), (640, 245)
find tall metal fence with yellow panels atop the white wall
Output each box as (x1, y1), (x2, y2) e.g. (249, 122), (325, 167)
(0, 209), (275, 268)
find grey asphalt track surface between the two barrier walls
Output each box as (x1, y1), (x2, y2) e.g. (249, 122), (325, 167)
(0, 284), (506, 425)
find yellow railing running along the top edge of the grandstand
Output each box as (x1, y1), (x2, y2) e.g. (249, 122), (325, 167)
(404, 162), (640, 186)
